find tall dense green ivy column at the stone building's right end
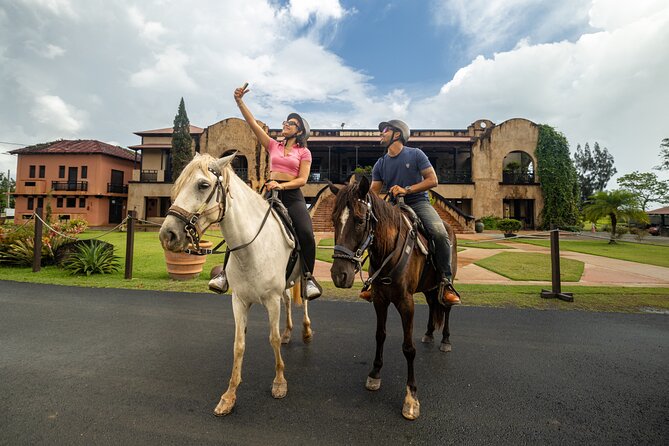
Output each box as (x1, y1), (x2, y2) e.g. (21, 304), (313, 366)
(536, 124), (580, 229)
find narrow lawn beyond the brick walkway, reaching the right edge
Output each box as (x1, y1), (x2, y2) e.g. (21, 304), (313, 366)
(515, 239), (669, 268)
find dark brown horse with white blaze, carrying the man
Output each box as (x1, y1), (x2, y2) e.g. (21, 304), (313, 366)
(330, 177), (457, 420)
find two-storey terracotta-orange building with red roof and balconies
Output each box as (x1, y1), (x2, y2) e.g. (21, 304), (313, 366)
(9, 140), (138, 226)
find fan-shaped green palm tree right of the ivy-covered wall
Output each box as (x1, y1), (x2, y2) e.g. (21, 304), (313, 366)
(583, 189), (648, 243)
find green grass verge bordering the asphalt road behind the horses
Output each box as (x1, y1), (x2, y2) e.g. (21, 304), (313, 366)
(0, 231), (669, 312)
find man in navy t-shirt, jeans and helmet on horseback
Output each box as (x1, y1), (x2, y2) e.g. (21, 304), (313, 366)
(362, 119), (460, 305)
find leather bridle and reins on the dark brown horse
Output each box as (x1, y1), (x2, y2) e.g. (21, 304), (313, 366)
(332, 194), (418, 291)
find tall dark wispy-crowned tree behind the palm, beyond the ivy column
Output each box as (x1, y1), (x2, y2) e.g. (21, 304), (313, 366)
(574, 142), (617, 202)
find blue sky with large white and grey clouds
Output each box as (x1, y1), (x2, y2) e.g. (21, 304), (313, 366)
(0, 0), (669, 188)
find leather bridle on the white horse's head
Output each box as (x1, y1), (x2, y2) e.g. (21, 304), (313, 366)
(167, 166), (230, 254)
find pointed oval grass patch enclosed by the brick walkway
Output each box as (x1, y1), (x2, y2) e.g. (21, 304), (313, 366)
(475, 252), (584, 282)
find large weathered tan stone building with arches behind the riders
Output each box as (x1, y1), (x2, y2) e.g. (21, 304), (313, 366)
(128, 118), (543, 232)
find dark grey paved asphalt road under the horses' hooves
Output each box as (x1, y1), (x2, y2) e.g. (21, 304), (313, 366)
(0, 282), (669, 446)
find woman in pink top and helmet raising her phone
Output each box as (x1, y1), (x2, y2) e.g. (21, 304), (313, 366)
(209, 86), (321, 300)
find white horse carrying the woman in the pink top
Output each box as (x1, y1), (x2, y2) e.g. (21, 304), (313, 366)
(160, 155), (313, 416)
